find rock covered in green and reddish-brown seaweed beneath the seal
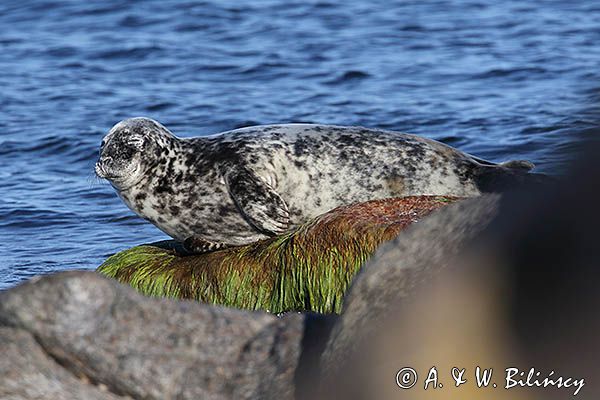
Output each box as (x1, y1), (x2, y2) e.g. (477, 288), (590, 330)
(98, 196), (458, 313)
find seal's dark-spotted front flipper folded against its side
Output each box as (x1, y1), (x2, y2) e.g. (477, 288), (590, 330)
(225, 167), (290, 235)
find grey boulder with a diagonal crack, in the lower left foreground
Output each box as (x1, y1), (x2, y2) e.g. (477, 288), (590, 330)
(0, 272), (303, 399)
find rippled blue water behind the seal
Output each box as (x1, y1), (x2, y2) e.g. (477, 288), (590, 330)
(0, 0), (600, 288)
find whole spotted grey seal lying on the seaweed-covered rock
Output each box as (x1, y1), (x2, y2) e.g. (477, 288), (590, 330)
(95, 117), (536, 253)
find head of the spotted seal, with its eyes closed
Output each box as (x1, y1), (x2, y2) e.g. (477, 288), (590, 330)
(95, 118), (174, 191)
